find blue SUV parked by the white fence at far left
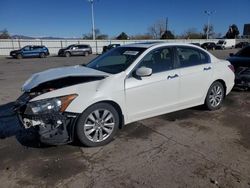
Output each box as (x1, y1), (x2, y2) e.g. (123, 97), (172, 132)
(10, 45), (49, 59)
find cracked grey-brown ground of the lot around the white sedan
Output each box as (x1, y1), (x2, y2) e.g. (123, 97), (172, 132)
(0, 50), (250, 188)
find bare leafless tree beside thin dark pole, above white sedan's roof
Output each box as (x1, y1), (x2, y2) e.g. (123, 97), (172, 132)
(148, 20), (166, 39)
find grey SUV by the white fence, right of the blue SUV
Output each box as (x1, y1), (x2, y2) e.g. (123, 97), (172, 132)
(58, 44), (92, 57)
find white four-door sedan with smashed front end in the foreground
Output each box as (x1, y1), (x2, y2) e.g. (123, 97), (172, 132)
(16, 43), (234, 146)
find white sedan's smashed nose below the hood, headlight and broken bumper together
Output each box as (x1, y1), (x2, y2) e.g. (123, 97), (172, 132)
(16, 93), (78, 145)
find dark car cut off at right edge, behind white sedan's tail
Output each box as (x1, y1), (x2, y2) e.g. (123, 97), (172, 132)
(227, 46), (250, 89)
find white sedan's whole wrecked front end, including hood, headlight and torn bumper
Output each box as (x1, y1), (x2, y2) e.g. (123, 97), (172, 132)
(15, 65), (109, 145)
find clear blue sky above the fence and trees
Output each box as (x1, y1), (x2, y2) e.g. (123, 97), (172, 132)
(0, 0), (250, 37)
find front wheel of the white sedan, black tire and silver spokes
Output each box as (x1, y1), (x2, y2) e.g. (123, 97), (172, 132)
(76, 103), (119, 147)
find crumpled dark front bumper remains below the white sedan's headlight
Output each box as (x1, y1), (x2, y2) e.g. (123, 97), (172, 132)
(15, 93), (79, 145)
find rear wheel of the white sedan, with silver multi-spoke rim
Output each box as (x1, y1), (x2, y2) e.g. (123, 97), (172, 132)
(205, 81), (225, 111)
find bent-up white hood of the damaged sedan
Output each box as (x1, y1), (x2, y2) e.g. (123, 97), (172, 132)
(22, 65), (110, 92)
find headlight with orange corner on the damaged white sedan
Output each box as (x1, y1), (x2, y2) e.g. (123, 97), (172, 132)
(25, 94), (77, 115)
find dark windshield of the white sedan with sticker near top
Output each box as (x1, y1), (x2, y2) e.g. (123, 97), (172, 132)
(86, 47), (146, 74)
